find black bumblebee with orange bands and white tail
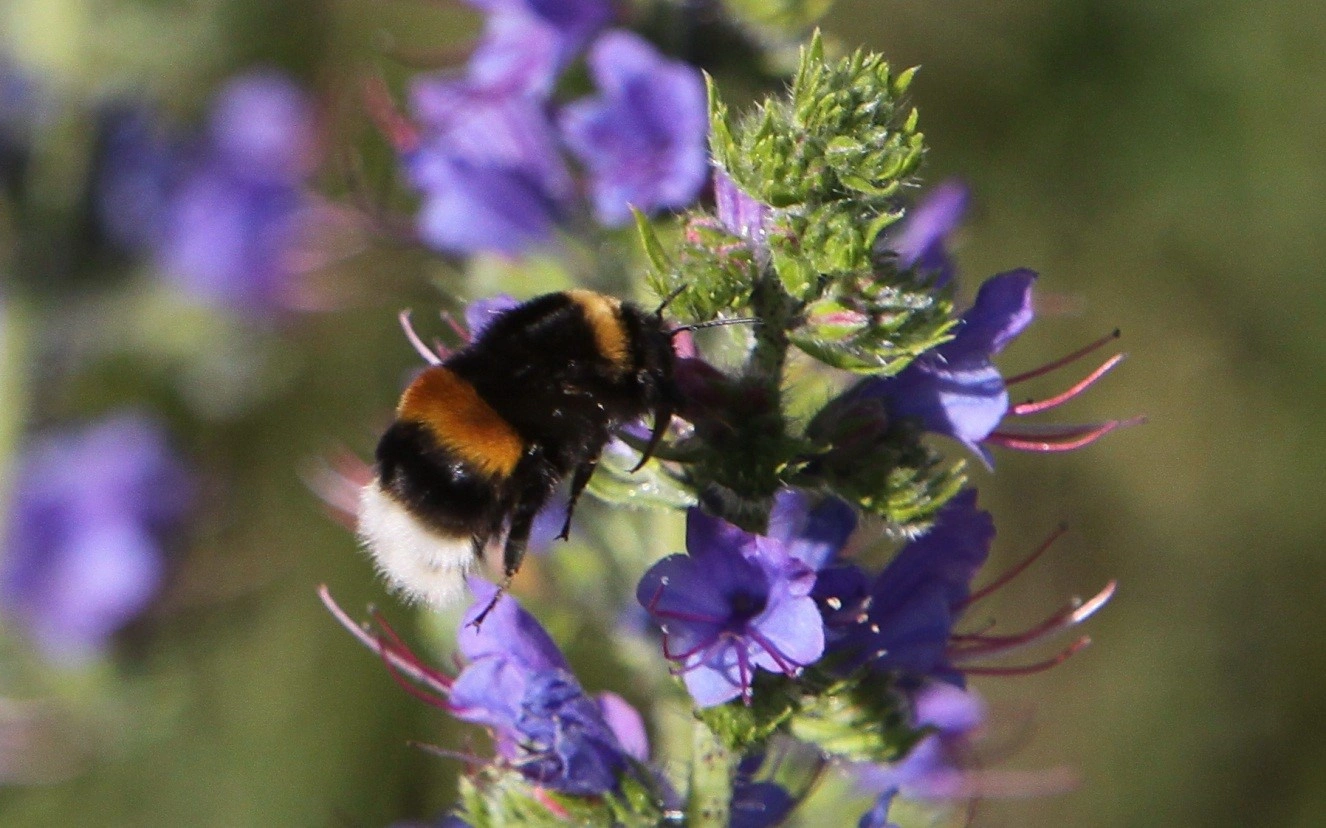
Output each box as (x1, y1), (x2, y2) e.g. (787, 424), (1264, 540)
(359, 291), (678, 605)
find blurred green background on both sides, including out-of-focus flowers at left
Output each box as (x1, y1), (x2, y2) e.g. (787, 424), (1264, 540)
(0, 0), (1326, 825)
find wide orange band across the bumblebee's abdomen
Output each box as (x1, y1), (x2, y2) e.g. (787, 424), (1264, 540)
(396, 366), (525, 478)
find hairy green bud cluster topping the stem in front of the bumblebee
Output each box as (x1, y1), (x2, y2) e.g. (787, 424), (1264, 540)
(636, 33), (964, 533)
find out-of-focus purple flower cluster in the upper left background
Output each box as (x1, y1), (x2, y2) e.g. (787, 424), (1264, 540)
(98, 72), (316, 314)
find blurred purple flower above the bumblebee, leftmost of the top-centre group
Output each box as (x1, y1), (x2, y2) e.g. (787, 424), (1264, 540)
(404, 78), (573, 255)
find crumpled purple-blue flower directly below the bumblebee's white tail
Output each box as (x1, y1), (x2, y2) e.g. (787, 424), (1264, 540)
(447, 579), (648, 796)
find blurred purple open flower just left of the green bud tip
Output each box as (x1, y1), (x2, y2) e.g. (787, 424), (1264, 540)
(561, 31), (709, 227)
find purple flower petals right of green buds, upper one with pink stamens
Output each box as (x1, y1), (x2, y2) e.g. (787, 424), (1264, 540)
(849, 269), (1036, 466)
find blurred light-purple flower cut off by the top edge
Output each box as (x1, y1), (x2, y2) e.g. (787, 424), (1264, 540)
(468, 0), (613, 97)
